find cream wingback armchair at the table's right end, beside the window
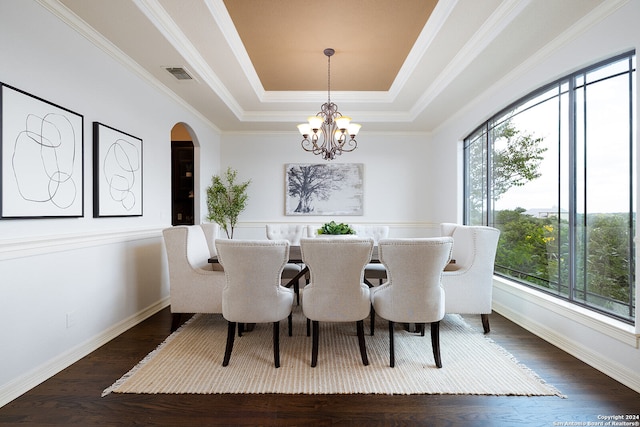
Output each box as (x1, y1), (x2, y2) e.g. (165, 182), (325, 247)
(440, 223), (500, 334)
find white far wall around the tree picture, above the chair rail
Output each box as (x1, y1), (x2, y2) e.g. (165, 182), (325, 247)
(221, 132), (456, 237)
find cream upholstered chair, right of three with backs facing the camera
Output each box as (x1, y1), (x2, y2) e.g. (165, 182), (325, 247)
(371, 237), (453, 368)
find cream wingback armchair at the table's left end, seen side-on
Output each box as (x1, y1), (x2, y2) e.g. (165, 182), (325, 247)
(162, 224), (225, 331)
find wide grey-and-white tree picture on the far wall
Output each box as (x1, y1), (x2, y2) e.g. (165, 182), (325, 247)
(285, 163), (364, 215)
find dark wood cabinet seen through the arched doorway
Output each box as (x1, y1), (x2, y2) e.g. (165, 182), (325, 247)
(171, 141), (194, 225)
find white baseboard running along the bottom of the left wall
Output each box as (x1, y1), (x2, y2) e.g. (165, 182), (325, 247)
(0, 297), (170, 408)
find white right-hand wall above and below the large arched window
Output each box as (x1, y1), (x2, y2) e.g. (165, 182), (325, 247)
(433, 1), (640, 391)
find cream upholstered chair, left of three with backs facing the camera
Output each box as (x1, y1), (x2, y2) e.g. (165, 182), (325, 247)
(216, 240), (293, 368)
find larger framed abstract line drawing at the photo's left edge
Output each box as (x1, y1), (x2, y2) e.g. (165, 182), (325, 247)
(0, 84), (84, 218)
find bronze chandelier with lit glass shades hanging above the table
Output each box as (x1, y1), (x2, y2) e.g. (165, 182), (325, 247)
(298, 48), (360, 160)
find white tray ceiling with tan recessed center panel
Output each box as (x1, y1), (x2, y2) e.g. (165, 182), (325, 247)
(46, 0), (608, 133)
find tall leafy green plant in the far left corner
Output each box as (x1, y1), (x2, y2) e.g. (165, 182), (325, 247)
(207, 167), (251, 239)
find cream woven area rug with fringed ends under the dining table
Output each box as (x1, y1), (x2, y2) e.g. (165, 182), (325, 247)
(102, 307), (564, 397)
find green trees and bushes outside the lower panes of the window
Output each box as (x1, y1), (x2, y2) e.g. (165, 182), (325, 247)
(495, 209), (633, 310)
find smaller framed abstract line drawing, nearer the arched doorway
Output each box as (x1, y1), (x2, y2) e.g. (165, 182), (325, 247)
(93, 122), (142, 218)
